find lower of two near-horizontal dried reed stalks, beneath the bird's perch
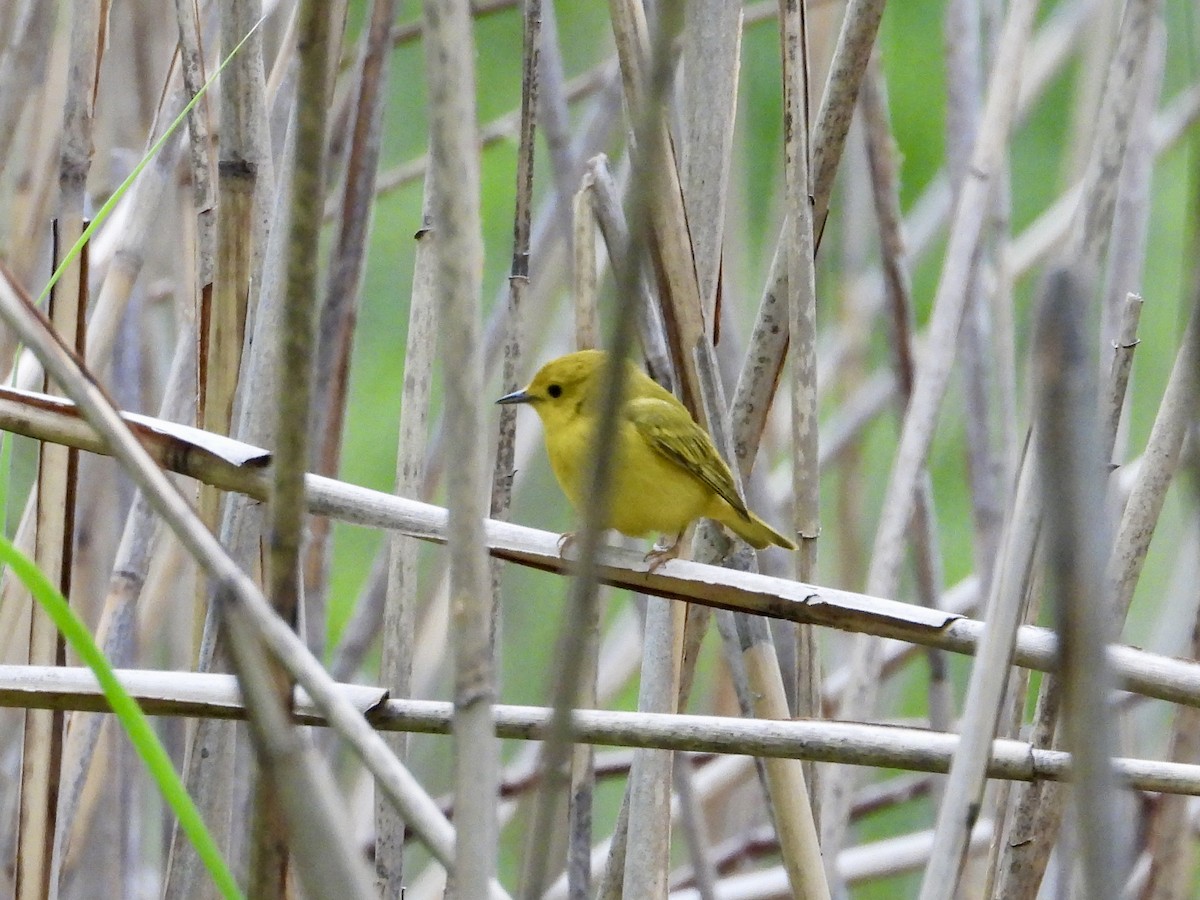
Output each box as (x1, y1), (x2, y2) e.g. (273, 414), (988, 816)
(7, 666), (1200, 801)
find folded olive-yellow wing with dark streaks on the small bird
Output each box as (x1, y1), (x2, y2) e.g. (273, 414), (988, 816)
(625, 397), (750, 521)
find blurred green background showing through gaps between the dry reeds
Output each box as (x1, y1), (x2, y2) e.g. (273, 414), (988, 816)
(330, 0), (1195, 898)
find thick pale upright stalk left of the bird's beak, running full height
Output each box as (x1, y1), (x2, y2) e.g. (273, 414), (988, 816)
(424, 0), (499, 898)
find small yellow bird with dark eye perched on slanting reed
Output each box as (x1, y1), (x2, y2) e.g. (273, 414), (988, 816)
(497, 350), (796, 571)
